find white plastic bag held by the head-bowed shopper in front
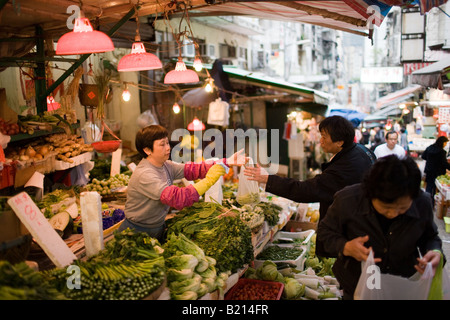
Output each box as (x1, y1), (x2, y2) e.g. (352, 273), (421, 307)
(354, 251), (433, 300)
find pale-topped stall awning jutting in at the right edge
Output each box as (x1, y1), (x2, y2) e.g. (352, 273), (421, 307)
(412, 57), (450, 90)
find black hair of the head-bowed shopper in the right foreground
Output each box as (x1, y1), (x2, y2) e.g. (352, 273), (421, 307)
(363, 155), (422, 203)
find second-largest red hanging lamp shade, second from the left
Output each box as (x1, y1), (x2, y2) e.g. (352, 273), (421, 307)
(117, 42), (162, 71)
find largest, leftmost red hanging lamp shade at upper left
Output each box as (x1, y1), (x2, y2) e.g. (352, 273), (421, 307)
(56, 18), (114, 55)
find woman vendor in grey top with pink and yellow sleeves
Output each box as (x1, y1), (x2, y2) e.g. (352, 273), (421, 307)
(119, 125), (245, 242)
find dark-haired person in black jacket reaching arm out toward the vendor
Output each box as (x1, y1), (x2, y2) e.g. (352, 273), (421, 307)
(244, 116), (376, 252)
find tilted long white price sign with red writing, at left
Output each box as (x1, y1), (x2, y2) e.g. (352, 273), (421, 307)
(8, 192), (77, 268)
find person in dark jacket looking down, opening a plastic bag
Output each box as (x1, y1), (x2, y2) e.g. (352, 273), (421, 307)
(317, 155), (445, 299)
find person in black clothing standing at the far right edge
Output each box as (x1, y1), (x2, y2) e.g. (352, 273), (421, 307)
(422, 136), (450, 206)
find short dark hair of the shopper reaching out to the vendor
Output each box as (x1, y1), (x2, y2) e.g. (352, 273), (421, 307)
(319, 116), (355, 148)
